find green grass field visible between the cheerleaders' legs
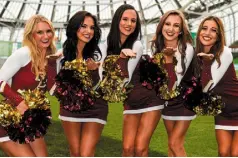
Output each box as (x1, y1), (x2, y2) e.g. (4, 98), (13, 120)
(0, 94), (217, 157)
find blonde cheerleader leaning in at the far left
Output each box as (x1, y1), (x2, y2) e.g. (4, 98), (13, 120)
(0, 15), (56, 157)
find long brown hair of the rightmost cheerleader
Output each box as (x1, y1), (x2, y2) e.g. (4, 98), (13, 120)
(195, 16), (226, 67)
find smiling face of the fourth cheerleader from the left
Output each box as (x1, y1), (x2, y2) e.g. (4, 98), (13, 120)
(162, 15), (182, 43)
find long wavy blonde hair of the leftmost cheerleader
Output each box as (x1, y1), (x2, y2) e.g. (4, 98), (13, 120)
(23, 15), (56, 77)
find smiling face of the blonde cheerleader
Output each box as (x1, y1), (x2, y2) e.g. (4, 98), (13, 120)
(33, 22), (53, 49)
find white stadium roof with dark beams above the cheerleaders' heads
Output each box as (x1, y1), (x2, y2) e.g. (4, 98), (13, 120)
(0, 0), (238, 43)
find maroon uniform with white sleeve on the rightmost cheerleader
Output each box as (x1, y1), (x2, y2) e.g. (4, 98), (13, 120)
(201, 47), (238, 130)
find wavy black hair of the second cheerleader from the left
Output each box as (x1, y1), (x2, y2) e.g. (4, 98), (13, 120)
(62, 11), (101, 64)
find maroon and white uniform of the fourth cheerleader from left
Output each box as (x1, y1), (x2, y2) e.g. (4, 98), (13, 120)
(162, 44), (196, 120)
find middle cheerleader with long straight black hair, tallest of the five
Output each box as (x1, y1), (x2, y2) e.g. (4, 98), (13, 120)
(100, 4), (163, 157)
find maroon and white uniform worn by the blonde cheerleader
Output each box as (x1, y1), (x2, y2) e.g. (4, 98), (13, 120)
(0, 47), (56, 142)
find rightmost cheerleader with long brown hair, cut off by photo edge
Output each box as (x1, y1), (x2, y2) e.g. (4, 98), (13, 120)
(196, 16), (238, 157)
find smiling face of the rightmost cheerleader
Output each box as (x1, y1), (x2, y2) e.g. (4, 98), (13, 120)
(199, 20), (218, 52)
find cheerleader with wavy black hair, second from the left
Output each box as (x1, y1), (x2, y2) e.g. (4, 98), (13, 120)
(55, 11), (105, 157)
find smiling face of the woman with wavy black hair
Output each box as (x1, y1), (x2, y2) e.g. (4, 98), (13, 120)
(77, 16), (94, 43)
